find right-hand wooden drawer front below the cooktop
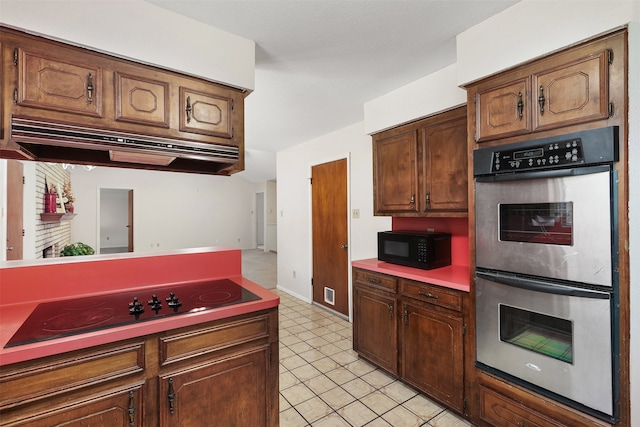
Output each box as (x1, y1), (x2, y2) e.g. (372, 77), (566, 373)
(160, 315), (269, 366)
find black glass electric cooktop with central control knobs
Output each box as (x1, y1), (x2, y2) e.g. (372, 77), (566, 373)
(5, 279), (262, 348)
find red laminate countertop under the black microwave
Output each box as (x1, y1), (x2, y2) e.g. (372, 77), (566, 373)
(351, 258), (470, 292)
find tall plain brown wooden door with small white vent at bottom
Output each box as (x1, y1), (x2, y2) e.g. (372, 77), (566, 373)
(311, 159), (349, 316)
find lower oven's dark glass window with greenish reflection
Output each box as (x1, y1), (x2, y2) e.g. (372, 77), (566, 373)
(500, 304), (573, 363)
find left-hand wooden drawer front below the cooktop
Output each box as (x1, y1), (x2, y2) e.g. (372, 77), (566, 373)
(0, 342), (145, 410)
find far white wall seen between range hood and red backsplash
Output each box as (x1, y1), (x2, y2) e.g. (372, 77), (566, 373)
(71, 167), (254, 252)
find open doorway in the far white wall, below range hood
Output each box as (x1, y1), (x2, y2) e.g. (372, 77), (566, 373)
(98, 188), (133, 254)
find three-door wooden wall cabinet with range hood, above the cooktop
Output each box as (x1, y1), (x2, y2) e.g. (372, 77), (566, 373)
(0, 27), (246, 174)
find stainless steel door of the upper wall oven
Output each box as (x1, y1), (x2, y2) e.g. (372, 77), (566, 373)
(475, 166), (612, 286)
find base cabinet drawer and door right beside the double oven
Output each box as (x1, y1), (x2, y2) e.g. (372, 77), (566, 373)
(400, 279), (464, 413)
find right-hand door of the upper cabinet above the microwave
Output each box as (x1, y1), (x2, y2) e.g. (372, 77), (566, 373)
(420, 113), (468, 212)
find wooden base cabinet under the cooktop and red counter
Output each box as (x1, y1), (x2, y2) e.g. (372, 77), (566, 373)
(0, 308), (279, 427)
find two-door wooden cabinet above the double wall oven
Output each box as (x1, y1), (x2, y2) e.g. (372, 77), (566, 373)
(467, 33), (616, 142)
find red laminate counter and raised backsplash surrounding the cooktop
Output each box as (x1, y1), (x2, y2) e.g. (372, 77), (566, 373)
(0, 248), (280, 366)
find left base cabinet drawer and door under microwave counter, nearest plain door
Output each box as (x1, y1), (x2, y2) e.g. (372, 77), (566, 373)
(353, 269), (398, 375)
